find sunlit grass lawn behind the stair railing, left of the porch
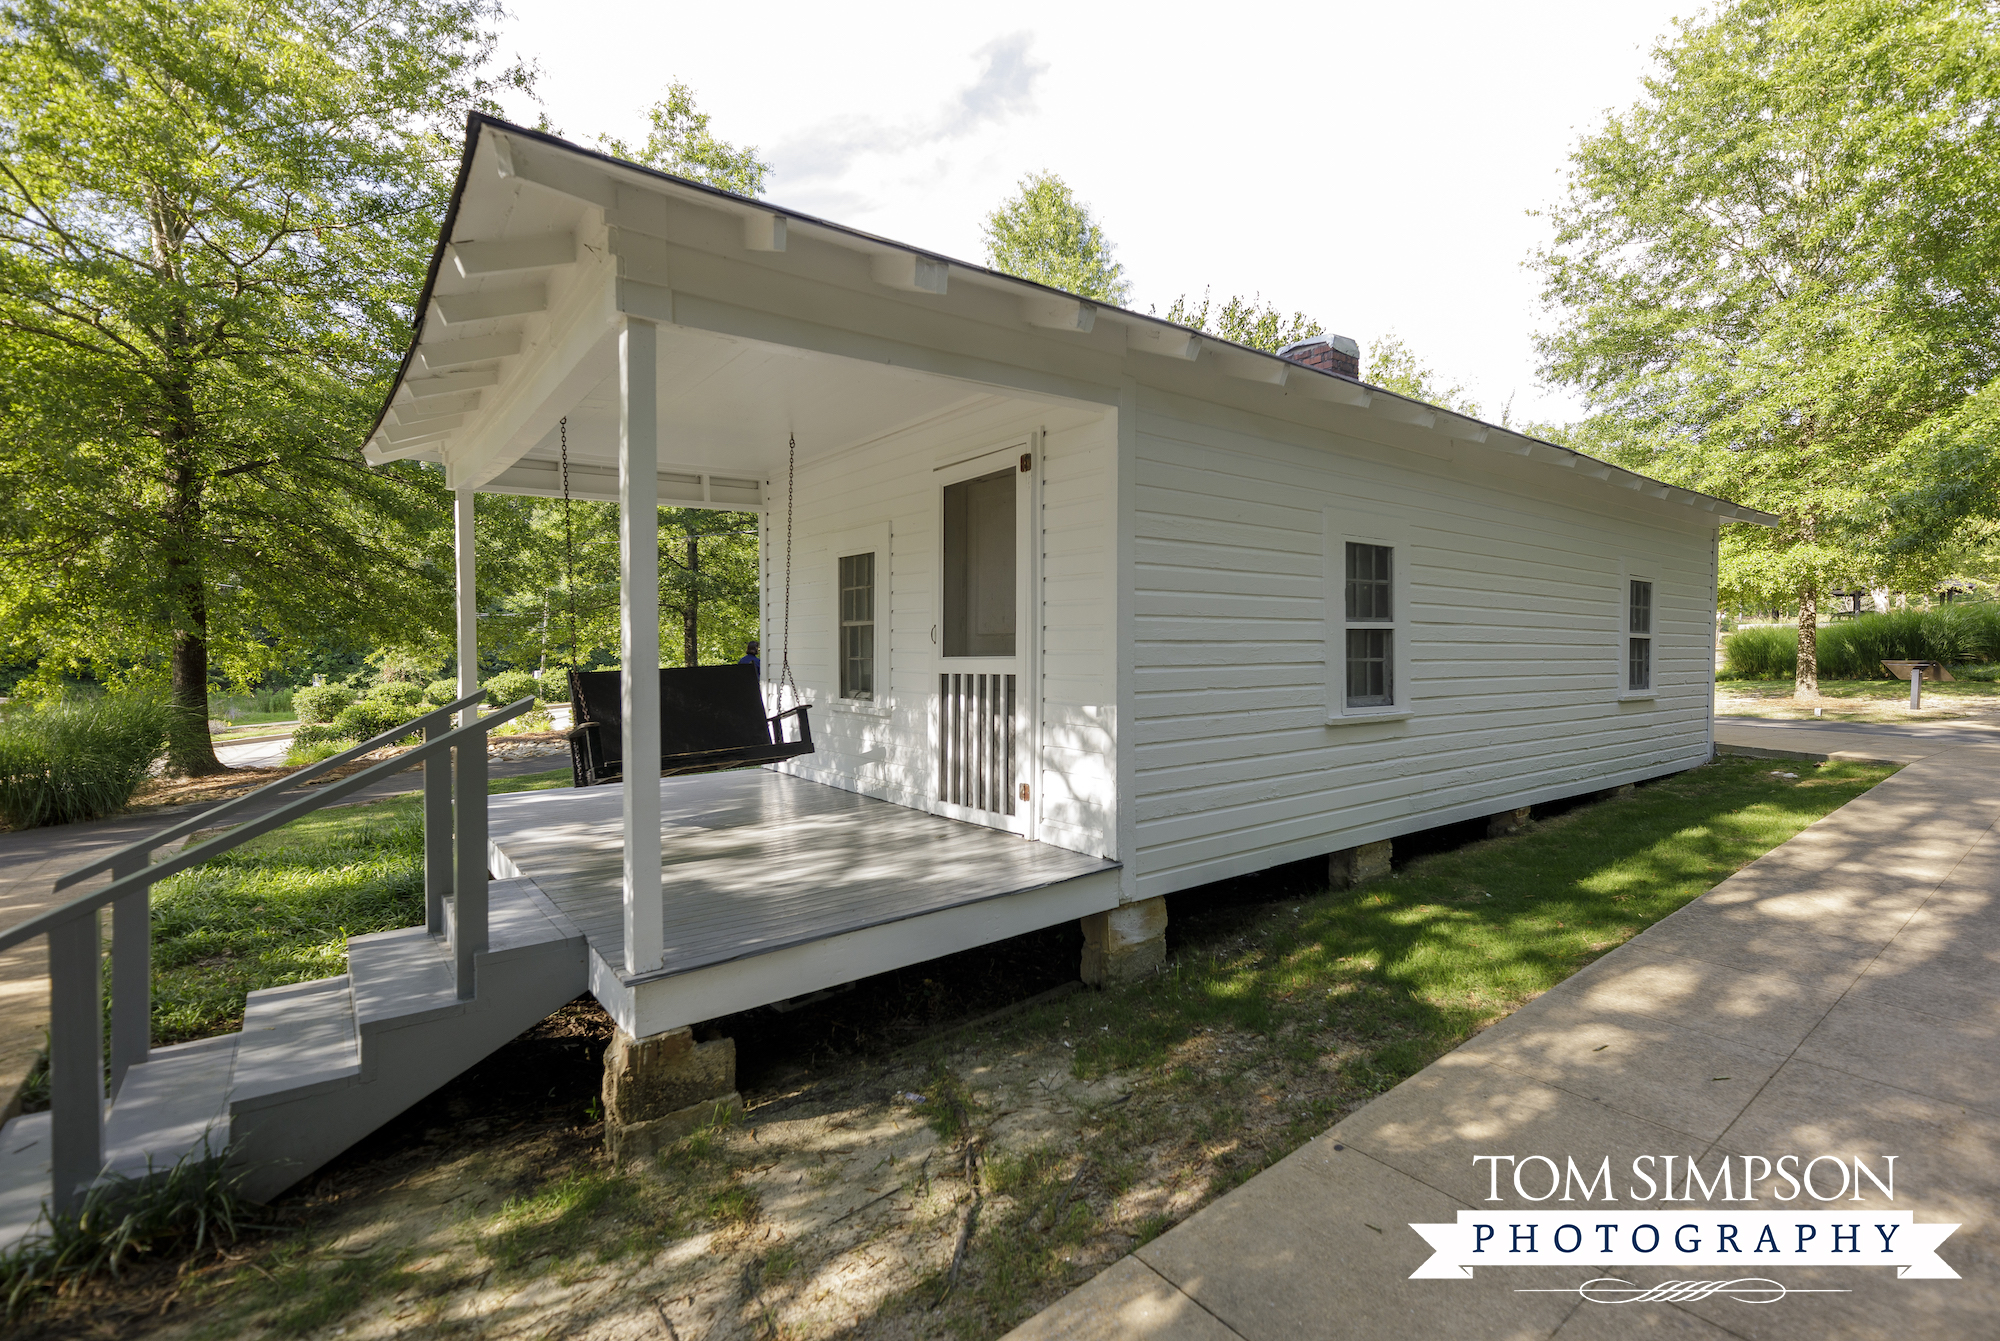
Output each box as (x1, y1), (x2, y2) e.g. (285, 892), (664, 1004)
(152, 769), (570, 1047)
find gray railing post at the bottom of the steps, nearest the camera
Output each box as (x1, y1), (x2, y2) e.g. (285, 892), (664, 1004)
(48, 911), (104, 1215)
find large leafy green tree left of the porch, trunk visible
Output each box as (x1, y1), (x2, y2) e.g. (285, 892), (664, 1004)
(0, 0), (526, 773)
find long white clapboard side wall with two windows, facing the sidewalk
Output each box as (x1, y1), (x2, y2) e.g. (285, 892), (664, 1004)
(1122, 392), (1714, 897)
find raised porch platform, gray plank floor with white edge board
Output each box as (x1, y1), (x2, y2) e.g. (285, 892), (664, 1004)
(488, 769), (1118, 1037)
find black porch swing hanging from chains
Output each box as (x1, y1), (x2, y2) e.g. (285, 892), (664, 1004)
(562, 426), (812, 787)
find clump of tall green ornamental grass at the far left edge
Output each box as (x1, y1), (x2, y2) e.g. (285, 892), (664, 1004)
(0, 697), (174, 829)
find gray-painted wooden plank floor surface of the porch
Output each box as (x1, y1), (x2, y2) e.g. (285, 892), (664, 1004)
(488, 769), (1118, 977)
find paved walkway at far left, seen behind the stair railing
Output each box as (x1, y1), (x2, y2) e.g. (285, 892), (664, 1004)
(0, 756), (564, 1119)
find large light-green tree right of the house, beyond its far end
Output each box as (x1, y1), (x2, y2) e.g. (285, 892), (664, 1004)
(1532, 0), (2000, 697)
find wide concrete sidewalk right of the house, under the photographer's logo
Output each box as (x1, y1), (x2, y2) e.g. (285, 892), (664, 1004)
(1012, 740), (2000, 1341)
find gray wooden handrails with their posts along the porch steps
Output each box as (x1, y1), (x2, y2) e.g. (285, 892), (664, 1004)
(25, 695), (534, 1213)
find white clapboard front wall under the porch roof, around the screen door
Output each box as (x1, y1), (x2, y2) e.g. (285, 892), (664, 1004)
(764, 396), (1116, 857)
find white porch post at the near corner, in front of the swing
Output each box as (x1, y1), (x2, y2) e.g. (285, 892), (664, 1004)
(618, 316), (666, 973)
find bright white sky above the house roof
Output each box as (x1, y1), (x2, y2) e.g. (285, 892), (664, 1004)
(484, 0), (1688, 424)
